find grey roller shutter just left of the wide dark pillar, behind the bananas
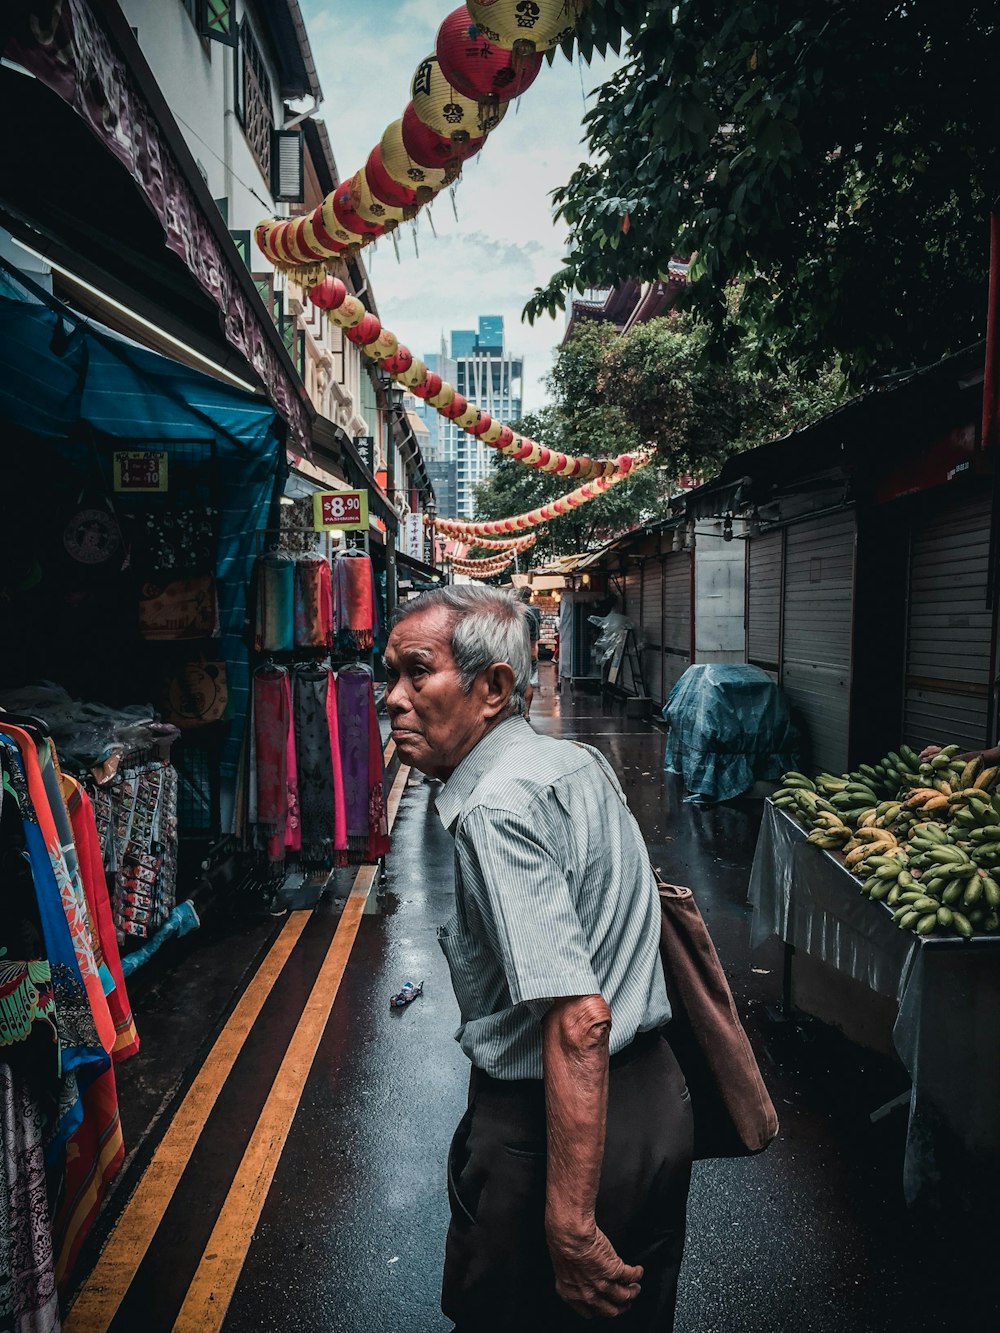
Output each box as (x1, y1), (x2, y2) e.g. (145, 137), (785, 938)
(781, 511), (855, 773)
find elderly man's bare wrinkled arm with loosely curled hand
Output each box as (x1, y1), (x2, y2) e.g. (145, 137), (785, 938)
(543, 994), (643, 1318)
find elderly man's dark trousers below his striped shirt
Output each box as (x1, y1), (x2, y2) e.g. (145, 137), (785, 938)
(441, 1032), (692, 1333)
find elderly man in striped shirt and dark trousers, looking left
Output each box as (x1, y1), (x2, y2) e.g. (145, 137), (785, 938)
(385, 585), (692, 1333)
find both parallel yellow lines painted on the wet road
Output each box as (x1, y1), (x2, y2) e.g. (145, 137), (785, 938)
(63, 762), (409, 1333)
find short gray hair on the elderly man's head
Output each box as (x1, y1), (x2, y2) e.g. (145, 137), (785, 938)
(393, 584), (531, 717)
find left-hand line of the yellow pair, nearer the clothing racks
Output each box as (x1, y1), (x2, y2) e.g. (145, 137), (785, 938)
(63, 912), (311, 1333)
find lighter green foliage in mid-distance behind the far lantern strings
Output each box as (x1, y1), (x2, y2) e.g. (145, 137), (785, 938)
(476, 313), (845, 551)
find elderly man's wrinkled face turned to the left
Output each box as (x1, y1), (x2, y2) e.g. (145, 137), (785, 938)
(385, 607), (493, 777)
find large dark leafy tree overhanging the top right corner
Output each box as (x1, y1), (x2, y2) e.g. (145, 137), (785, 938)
(527, 0), (1000, 384)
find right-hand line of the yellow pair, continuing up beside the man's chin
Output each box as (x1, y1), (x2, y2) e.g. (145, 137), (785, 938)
(173, 766), (409, 1333)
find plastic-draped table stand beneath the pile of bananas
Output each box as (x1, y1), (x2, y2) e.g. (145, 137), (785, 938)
(749, 801), (1000, 1208)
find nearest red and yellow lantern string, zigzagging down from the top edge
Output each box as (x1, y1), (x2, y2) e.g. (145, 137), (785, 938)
(255, 0), (650, 481)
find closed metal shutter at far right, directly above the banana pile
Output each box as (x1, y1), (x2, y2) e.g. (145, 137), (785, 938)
(903, 500), (993, 749)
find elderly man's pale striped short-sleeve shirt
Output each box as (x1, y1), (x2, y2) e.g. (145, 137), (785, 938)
(437, 718), (671, 1078)
